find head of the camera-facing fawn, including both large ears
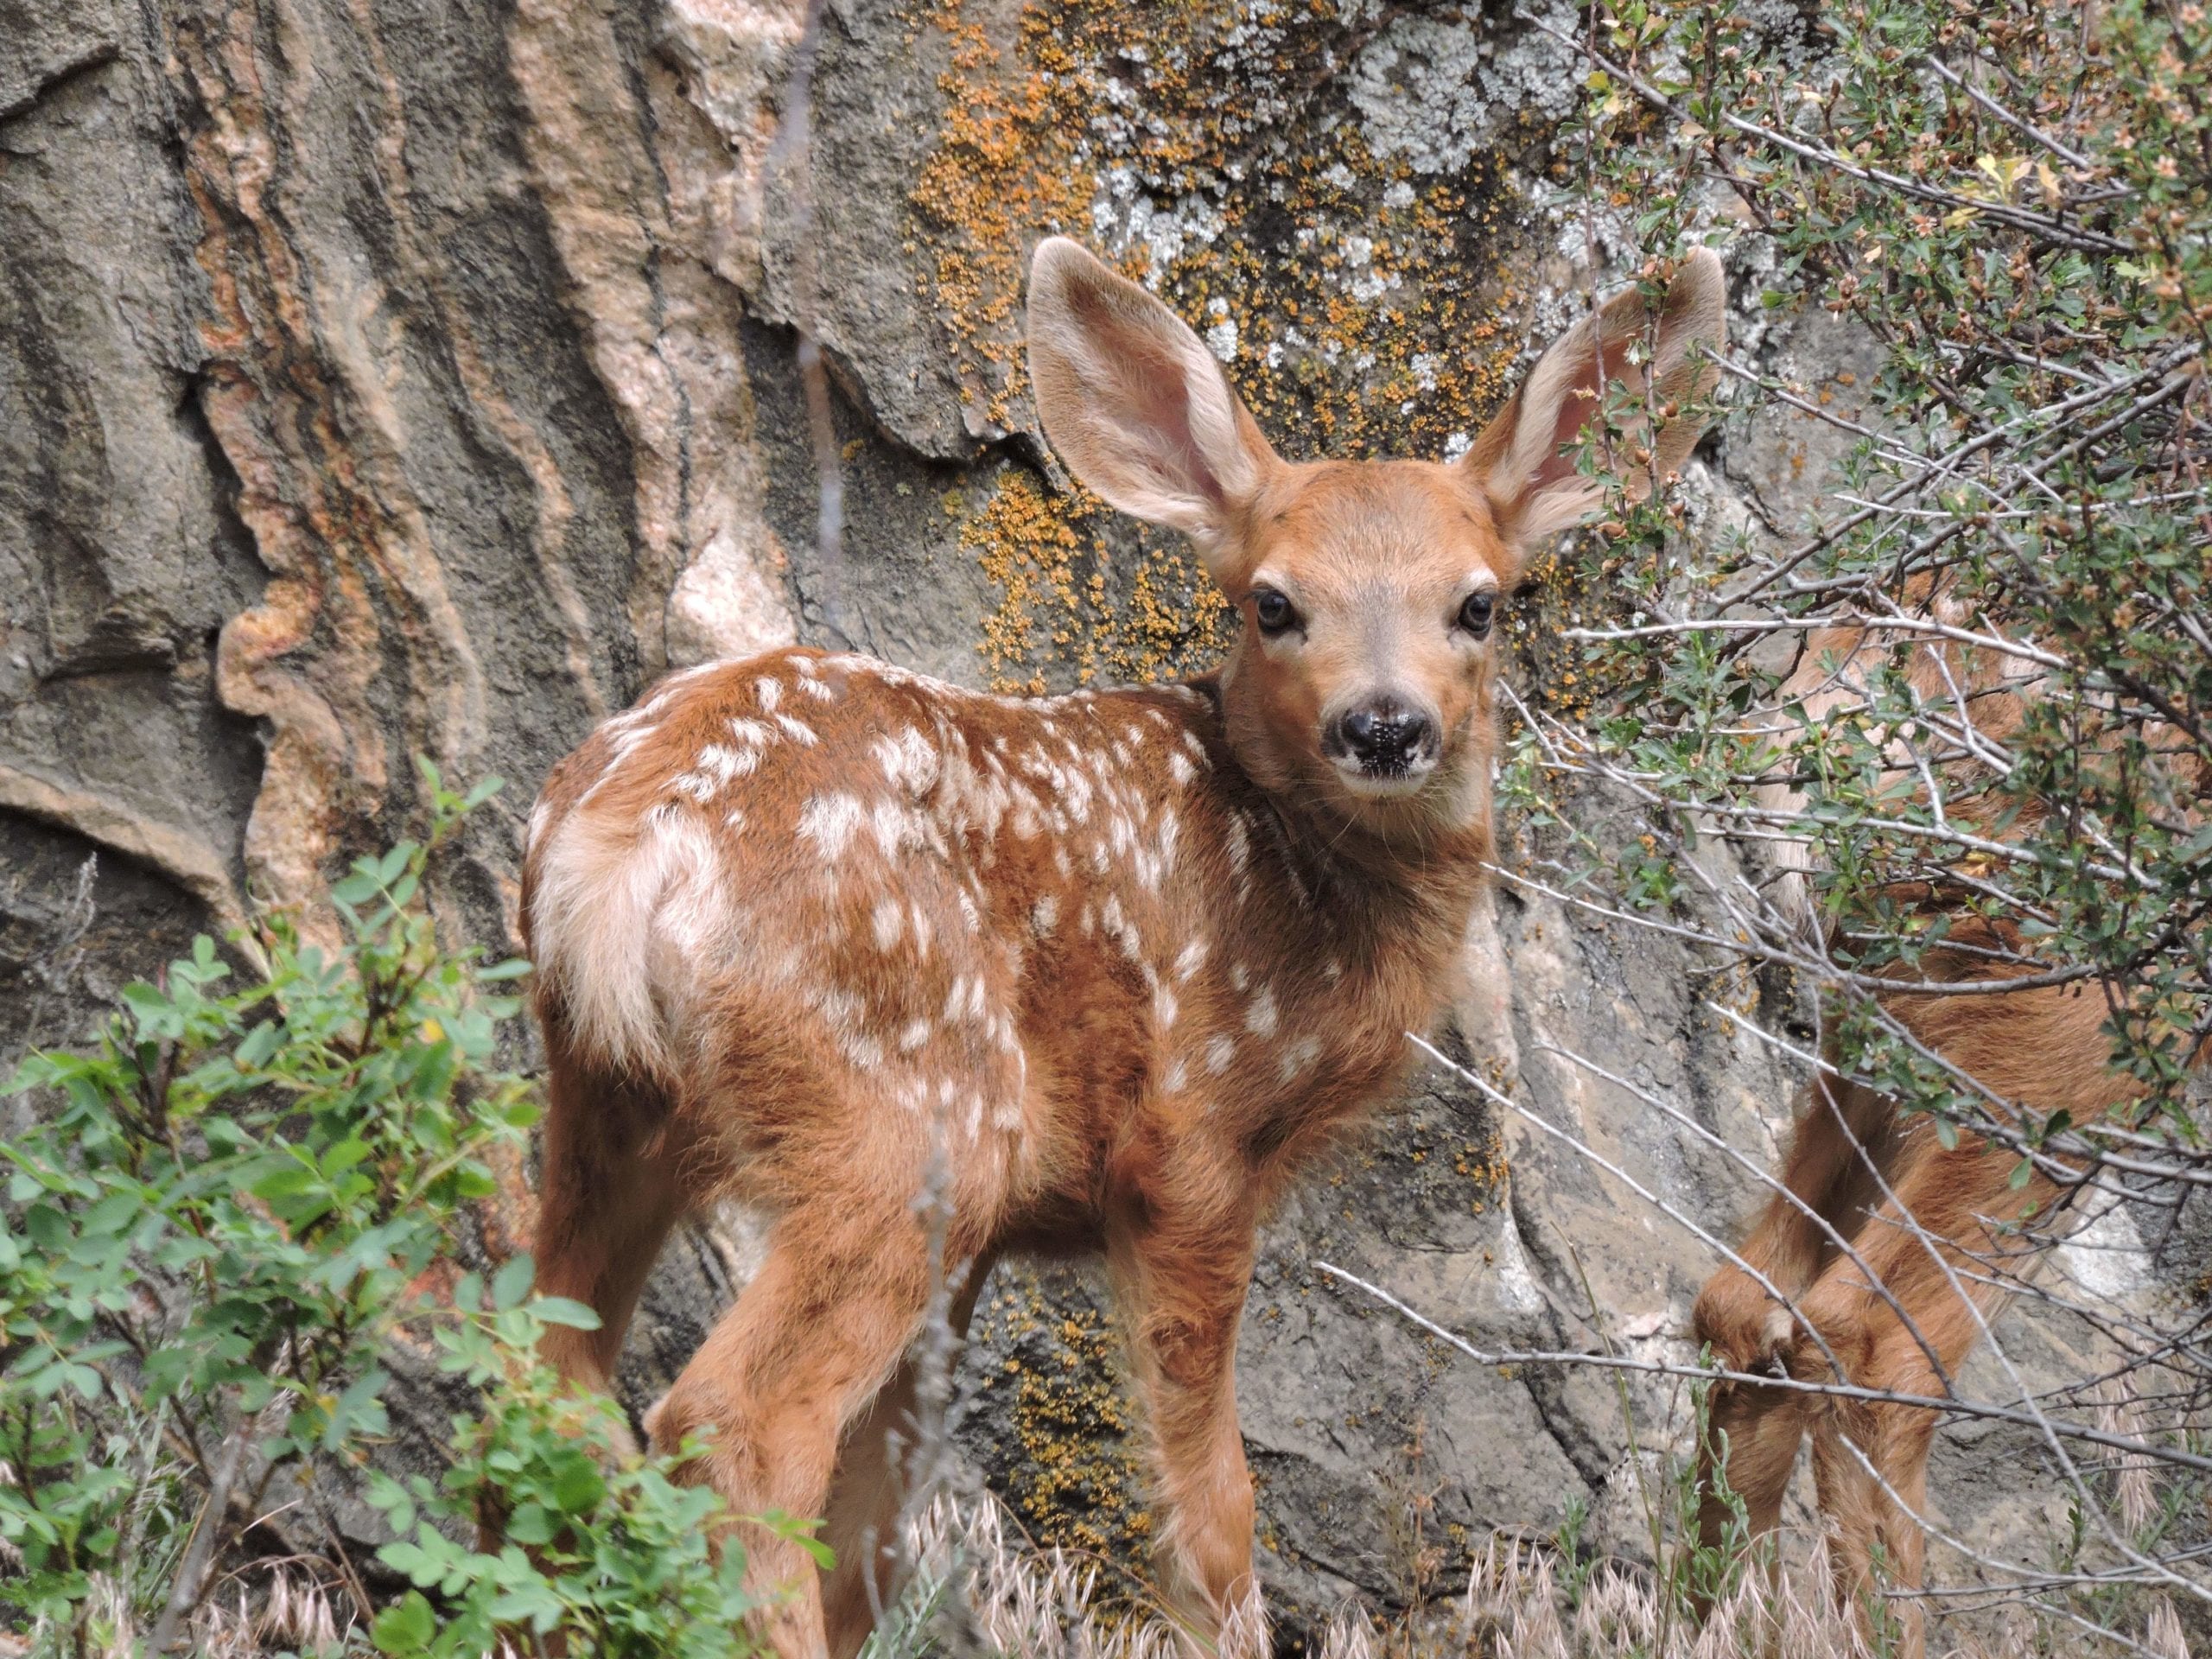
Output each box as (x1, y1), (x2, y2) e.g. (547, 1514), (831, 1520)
(1028, 237), (1726, 830)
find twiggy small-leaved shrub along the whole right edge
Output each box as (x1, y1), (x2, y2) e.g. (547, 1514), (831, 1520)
(1506, 0), (2212, 1642)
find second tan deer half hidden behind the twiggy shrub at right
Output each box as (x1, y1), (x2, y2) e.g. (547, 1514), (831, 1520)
(1694, 606), (2177, 1659)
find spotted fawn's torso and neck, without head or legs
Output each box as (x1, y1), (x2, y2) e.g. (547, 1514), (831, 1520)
(526, 651), (1486, 1232)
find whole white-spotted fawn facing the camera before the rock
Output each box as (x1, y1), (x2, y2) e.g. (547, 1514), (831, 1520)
(524, 238), (1723, 1655)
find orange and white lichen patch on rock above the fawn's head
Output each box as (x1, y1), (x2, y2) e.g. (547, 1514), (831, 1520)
(913, 0), (1520, 454)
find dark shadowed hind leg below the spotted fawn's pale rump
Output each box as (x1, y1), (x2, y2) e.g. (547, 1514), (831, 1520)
(536, 1020), (686, 1433)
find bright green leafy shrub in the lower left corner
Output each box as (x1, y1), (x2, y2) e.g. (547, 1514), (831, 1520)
(0, 766), (779, 1655)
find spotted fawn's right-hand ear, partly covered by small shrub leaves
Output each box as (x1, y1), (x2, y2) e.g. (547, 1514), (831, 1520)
(1460, 248), (1727, 560)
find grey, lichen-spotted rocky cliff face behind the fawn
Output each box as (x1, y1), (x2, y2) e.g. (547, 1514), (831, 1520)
(0, 0), (2123, 1628)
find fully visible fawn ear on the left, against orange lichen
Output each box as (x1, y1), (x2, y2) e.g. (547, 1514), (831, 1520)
(1028, 237), (1281, 577)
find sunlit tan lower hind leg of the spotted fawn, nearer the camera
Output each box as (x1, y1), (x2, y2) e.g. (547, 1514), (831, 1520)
(652, 1194), (929, 1659)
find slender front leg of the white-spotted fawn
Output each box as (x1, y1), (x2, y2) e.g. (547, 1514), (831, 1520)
(1109, 1205), (1265, 1659)
